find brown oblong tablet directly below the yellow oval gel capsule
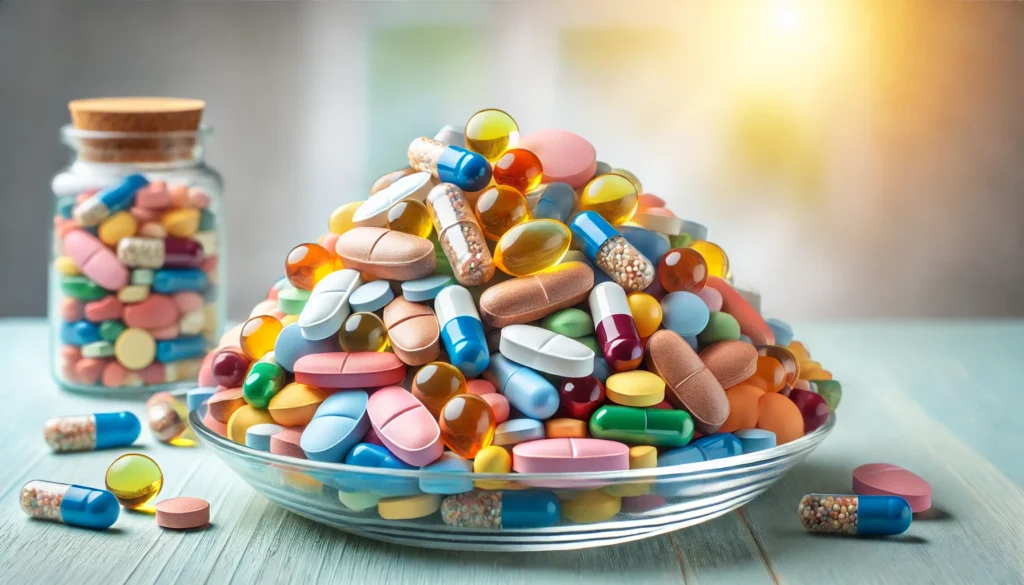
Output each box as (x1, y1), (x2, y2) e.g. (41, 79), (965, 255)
(480, 262), (594, 327)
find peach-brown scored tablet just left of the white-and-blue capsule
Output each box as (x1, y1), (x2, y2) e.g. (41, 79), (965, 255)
(384, 296), (441, 366)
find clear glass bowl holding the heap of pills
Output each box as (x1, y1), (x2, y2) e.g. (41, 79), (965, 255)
(189, 405), (836, 551)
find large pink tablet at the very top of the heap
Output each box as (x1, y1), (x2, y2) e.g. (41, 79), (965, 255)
(519, 128), (597, 189)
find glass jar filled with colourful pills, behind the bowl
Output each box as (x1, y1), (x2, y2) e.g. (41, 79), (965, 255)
(49, 102), (224, 394)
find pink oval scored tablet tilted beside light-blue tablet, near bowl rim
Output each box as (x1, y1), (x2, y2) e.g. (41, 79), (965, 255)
(367, 386), (444, 466)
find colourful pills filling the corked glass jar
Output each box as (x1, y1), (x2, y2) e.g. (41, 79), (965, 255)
(53, 174), (218, 388)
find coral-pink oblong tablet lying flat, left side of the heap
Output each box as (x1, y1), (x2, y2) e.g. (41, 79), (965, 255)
(295, 351), (406, 389)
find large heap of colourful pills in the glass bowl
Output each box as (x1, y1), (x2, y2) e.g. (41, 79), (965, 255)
(186, 110), (842, 528)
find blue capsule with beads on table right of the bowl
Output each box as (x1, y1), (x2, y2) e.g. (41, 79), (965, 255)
(798, 494), (912, 536)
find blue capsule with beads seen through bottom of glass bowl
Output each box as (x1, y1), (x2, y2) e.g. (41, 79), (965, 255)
(441, 490), (561, 530)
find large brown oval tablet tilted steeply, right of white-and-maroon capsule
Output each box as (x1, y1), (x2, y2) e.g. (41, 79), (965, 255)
(644, 329), (729, 434)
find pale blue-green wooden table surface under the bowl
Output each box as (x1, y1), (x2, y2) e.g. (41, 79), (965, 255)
(0, 320), (1024, 585)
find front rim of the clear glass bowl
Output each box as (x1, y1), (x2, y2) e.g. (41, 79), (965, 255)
(188, 404), (836, 489)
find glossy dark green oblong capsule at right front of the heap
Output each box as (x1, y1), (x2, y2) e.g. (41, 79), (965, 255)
(590, 405), (693, 447)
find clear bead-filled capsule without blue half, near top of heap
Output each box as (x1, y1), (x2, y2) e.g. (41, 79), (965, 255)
(427, 182), (495, 287)
